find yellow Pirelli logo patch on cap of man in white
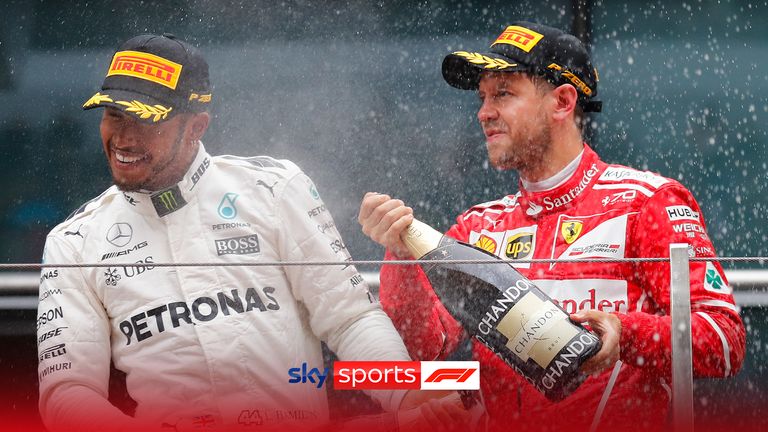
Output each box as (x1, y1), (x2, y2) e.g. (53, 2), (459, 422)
(107, 51), (182, 90)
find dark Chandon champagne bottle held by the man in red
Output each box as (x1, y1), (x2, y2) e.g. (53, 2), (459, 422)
(401, 220), (601, 401)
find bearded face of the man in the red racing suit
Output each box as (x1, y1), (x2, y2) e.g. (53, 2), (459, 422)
(477, 73), (552, 178)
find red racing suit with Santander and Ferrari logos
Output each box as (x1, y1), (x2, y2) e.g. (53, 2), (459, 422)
(380, 145), (745, 431)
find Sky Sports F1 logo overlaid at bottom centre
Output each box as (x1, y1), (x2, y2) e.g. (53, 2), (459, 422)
(288, 361), (480, 390)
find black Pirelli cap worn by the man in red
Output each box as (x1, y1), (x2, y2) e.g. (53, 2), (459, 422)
(443, 21), (602, 112)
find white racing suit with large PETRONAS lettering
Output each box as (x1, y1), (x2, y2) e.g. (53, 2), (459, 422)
(37, 144), (409, 430)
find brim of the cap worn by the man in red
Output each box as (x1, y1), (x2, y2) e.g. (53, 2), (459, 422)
(442, 51), (528, 90)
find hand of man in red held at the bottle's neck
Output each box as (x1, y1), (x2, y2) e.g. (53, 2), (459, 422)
(357, 192), (413, 258)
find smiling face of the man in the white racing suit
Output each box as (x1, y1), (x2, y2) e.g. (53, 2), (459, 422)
(100, 108), (207, 191)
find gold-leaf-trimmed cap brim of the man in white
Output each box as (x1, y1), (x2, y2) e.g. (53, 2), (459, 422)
(83, 90), (176, 123)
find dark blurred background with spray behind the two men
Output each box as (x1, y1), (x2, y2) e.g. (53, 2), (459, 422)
(0, 0), (768, 425)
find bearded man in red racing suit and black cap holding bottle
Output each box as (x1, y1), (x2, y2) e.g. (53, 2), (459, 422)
(359, 23), (745, 431)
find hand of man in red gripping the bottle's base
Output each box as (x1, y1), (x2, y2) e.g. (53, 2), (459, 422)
(571, 310), (621, 375)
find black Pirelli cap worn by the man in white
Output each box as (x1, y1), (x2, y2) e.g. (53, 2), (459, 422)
(83, 33), (211, 123)
